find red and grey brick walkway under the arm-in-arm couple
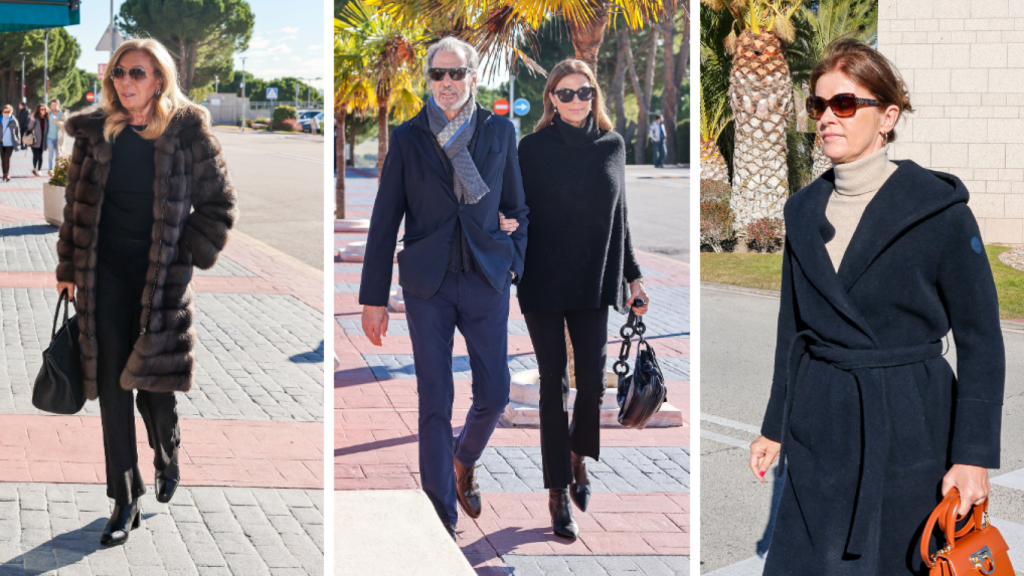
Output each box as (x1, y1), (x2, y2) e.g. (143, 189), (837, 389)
(334, 171), (690, 576)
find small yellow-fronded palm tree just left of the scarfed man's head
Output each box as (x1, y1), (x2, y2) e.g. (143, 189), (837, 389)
(334, 0), (426, 177)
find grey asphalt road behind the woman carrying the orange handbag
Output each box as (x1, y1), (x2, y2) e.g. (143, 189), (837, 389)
(700, 286), (1024, 576)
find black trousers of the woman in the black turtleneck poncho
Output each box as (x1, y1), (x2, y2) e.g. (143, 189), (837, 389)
(523, 306), (608, 488)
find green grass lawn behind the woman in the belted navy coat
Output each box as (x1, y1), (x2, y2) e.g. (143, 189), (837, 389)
(700, 246), (1024, 320)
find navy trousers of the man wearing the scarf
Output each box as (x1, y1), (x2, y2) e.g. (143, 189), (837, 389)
(406, 272), (512, 525)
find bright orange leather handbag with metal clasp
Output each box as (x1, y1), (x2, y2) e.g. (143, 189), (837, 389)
(921, 488), (1014, 576)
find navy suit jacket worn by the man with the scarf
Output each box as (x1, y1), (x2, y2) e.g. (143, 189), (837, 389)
(359, 105), (528, 306)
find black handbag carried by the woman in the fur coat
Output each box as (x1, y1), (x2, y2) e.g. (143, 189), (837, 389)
(32, 289), (85, 414)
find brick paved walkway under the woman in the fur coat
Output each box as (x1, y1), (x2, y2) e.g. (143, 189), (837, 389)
(0, 145), (324, 576)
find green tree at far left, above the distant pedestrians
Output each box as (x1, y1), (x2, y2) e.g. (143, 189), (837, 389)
(0, 28), (82, 106)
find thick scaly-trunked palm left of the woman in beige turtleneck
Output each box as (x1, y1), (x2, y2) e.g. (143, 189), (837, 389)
(700, 0), (802, 235)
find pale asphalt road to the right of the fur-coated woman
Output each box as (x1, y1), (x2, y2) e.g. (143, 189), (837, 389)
(214, 129), (325, 270)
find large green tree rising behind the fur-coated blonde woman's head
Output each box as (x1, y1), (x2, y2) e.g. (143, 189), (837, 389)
(118, 0), (256, 92)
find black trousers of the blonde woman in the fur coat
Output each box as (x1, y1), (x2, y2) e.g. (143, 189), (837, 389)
(95, 230), (181, 505)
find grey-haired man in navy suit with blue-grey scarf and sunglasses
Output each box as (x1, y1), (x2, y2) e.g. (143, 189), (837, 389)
(359, 37), (527, 538)
